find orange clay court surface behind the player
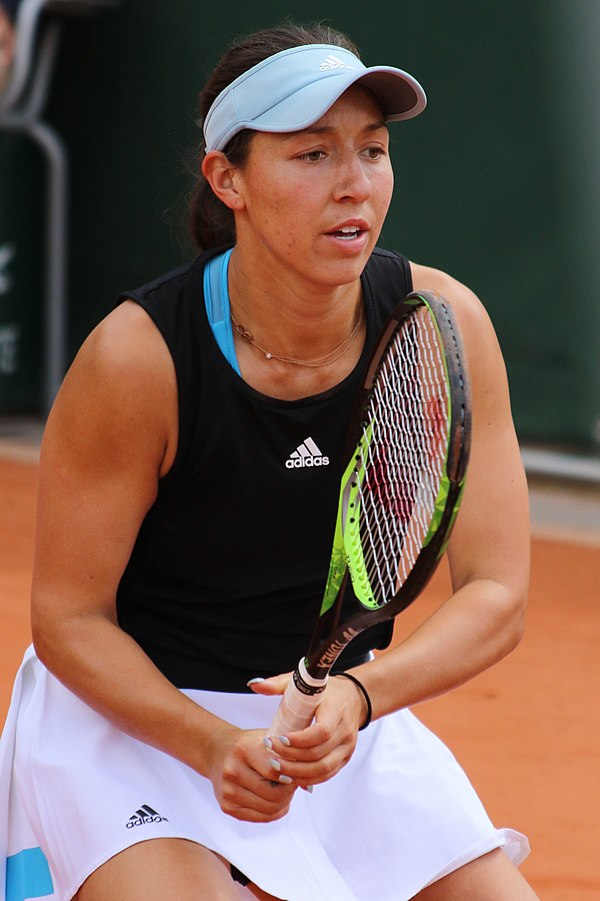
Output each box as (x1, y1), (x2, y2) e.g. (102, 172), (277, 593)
(0, 448), (600, 901)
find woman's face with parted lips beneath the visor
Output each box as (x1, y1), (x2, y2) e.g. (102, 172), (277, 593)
(233, 85), (393, 287)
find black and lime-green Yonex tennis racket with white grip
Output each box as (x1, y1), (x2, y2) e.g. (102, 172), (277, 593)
(269, 291), (471, 735)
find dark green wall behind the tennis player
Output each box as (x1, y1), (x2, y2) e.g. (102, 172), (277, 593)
(0, 0), (600, 451)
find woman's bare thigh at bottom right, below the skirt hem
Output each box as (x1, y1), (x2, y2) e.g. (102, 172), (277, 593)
(415, 849), (538, 901)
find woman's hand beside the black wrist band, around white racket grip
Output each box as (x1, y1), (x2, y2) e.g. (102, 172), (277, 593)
(250, 673), (366, 788)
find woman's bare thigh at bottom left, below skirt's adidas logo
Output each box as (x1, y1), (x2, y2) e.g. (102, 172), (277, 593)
(73, 838), (245, 901)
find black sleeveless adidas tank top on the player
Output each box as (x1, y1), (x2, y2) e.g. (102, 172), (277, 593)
(117, 248), (412, 691)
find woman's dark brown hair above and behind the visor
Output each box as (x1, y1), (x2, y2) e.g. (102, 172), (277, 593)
(190, 23), (358, 251)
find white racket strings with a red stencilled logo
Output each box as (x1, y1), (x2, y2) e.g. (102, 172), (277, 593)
(357, 307), (450, 605)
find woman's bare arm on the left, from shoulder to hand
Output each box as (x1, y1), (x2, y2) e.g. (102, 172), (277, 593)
(31, 303), (291, 820)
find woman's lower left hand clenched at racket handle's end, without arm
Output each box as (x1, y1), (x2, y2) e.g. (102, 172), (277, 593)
(207, 724), (297, 823)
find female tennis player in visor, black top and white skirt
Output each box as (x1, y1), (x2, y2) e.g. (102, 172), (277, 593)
(3, 25), (535, 901)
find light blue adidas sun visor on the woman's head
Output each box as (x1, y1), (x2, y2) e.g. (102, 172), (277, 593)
(204, 44), (427, 153)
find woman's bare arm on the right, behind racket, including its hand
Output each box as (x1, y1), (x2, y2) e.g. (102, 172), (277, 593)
(253, 266), (529, 784)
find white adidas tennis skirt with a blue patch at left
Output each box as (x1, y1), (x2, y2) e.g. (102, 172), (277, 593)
(0, 649), (529, 901)
